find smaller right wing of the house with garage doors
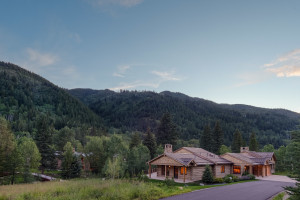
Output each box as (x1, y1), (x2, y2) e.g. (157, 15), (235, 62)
(221, 147), (276, 176)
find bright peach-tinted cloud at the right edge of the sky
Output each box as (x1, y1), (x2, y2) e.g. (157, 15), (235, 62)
(264, 49), (300, 77)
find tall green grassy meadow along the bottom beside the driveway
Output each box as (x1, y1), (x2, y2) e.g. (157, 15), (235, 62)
(0, 178), (258, 200)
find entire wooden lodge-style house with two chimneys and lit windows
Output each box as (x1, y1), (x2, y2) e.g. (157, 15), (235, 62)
(148, 144), (276, 182)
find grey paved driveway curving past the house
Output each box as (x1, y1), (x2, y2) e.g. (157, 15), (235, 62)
(164, 181), (295, 200)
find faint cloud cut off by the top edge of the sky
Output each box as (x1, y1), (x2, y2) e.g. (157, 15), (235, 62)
(89, 0), (143, 8)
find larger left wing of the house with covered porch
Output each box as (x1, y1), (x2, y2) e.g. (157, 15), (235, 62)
(148, 144), (233, 182)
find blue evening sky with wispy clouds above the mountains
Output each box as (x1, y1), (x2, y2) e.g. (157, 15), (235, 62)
(0, 0), (300, 113)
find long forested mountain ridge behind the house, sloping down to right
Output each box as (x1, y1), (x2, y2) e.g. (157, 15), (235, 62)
(69, 89), (300, 147)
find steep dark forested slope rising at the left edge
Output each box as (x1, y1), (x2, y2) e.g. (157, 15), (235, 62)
(0, 62), (103, 133)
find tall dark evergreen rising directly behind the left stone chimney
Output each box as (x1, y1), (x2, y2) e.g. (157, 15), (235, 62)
(156, 113), (178, 145)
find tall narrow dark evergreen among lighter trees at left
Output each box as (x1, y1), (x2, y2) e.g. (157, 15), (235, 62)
(35, 115), (55, 174)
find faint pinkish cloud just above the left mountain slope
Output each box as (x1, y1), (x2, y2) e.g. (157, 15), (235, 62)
(26, 48), (58, 67)
